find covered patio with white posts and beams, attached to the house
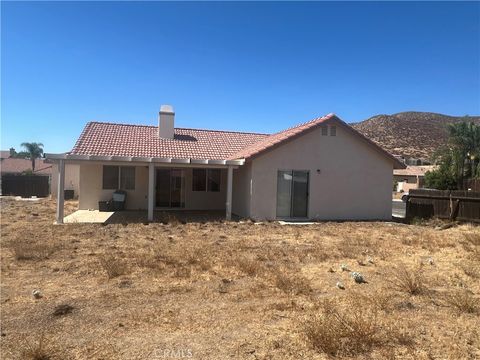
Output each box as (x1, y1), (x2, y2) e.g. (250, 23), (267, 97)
(46, 154), (244, 224)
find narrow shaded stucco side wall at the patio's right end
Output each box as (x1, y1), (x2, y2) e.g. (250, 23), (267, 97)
(232, 163), (252, 217)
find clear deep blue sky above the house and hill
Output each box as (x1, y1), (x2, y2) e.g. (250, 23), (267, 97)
(0, 1), (480, 153)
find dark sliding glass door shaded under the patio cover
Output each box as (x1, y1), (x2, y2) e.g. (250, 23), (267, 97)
(155, 169), (185, 208)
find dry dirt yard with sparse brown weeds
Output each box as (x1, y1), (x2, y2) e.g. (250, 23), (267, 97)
(0, 198), (480, 359)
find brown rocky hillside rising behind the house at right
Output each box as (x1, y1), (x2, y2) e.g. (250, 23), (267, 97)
(352, 111), (480, 159)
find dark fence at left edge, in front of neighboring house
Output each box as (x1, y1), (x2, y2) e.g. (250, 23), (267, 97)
(2, 174), (50, 197)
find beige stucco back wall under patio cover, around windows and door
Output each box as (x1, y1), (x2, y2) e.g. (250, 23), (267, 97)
(79, 163), (227, 210)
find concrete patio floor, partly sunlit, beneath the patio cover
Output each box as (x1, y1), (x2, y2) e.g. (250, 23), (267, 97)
(63, 210), (231, 224)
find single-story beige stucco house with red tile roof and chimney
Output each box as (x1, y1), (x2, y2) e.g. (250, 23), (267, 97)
(46, 105), (405, 223)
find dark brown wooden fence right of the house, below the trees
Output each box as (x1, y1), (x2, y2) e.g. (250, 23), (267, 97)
(406, 189), (480, 222)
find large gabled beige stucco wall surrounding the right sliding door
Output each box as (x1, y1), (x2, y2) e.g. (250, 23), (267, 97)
(251, 125), (393, 220)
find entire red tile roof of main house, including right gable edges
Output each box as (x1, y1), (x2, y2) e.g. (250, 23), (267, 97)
(70, 114), (405, 168)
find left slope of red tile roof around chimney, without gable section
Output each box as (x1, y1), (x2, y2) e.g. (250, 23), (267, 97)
(70, 122), (268, 160)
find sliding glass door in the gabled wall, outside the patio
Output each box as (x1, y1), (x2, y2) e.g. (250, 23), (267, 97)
(277, 170), (308, 218)
